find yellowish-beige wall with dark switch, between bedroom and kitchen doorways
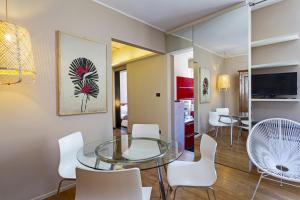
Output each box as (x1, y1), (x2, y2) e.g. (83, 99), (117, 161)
(127, 55), (170, 140)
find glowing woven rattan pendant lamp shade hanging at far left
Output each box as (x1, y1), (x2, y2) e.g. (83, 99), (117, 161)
(0, 21), (36, 84)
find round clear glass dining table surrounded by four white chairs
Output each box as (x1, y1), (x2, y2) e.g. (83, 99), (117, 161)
(77, 135), (184, 200)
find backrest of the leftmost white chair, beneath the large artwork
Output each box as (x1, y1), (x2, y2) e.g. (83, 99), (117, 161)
(58, 132), (83, 178)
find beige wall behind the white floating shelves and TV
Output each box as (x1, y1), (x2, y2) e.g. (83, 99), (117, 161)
(252, 0), (300, 121)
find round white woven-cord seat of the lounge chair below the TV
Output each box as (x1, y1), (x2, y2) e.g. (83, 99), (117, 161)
(247, 118), (300, 183)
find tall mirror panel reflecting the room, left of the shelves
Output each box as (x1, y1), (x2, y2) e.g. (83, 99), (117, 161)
(192, 6), (249, 171)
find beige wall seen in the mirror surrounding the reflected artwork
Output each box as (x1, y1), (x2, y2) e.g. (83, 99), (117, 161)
(194, 46), (224, 133)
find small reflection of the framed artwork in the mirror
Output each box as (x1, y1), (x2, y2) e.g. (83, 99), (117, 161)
(200, 67), (211, 103)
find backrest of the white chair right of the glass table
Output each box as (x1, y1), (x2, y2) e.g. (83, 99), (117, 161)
(200, 134), (217, 162)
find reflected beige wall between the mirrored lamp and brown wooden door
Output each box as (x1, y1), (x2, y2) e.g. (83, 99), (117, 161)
(224, 55), (248, 114)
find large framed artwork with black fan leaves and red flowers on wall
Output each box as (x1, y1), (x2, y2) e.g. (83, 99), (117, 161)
(56, 31), (107, 115)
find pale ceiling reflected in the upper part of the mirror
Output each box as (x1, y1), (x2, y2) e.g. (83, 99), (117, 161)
(174, 7), (249, 57)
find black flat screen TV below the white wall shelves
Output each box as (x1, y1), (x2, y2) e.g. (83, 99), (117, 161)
(251, 72), (297, 98)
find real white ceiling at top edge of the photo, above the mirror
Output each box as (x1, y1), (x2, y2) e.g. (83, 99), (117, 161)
(94, 0), (244, 31)
